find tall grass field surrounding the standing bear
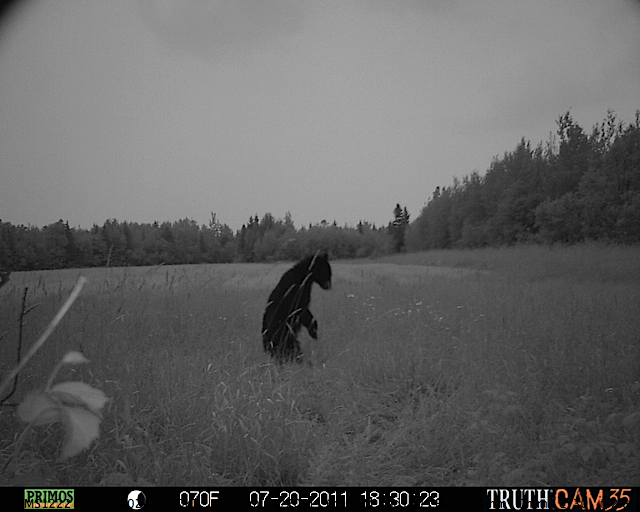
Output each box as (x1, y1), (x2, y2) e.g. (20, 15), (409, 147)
(0, 246), (640, 487)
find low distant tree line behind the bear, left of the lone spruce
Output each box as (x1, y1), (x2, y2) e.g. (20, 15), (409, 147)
(0, 209), (406, 271)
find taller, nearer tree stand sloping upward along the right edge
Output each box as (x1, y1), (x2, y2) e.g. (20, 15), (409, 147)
(406, 110), (640, 251)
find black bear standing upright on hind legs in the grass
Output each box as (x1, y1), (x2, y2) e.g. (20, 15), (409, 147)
(262, 251), (331, 363)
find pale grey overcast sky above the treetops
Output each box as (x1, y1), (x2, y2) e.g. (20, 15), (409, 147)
(0, 0), (640, 230)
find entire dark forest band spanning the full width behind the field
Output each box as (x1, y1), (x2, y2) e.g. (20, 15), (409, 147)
(0, 110), (640, 271)
